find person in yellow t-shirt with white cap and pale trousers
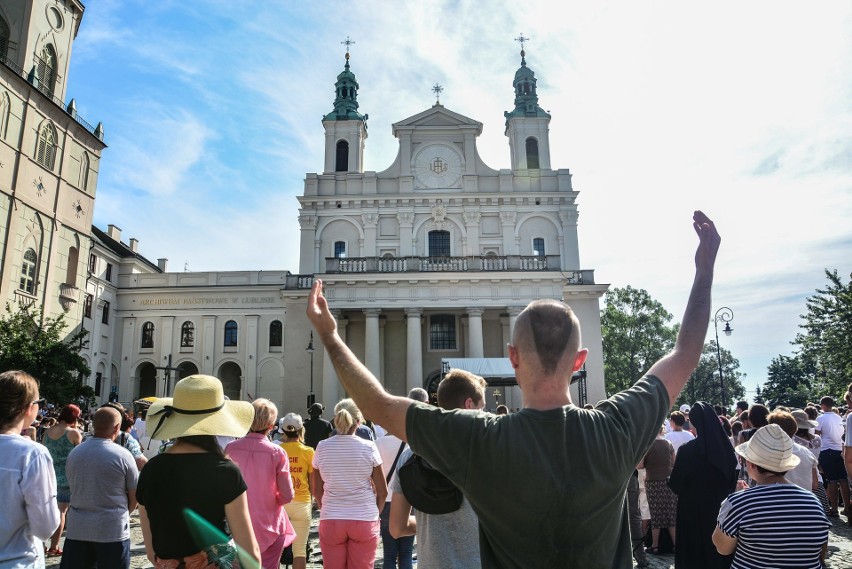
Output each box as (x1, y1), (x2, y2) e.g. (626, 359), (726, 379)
(278, 413), (314, 569)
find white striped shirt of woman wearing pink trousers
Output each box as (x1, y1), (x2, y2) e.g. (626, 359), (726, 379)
(313, 435), (382, 522)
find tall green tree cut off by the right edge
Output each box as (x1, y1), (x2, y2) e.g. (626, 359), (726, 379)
(793, 269), (852, 396)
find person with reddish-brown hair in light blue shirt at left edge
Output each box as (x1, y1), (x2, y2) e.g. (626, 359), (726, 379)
(0, 371), (59, 567)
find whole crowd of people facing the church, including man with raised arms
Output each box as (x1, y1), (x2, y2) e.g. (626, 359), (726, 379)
(0, 212), (852, 569)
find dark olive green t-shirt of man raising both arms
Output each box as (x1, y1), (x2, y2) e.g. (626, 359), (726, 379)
(406, 376), (669, 569)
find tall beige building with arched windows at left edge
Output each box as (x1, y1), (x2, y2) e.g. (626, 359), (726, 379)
(0, 0), (109, 326)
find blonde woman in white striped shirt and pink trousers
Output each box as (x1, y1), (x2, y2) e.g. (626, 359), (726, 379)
(311, 404), (388, 569)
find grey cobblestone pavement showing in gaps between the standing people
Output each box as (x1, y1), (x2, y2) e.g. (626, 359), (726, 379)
(47, 512), (852, 569)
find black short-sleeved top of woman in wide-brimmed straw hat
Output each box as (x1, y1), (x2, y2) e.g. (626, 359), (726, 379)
(136, 452), (247, 559)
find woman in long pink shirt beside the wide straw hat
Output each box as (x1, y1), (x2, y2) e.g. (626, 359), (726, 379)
(225, 399), (296, 569)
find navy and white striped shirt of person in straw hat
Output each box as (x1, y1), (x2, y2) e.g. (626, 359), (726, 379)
(718, 484), (831, 569)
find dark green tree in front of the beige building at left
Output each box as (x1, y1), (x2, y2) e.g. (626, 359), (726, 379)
(0, 304), (94, 405)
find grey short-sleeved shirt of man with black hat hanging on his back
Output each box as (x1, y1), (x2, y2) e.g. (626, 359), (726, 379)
(389, 448), (482, 569)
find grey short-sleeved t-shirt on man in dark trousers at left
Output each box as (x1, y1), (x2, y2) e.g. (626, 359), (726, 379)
(65, 437), (139, 543)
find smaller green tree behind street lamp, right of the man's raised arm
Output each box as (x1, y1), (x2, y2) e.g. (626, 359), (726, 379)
(676, 340), (745, 408)
